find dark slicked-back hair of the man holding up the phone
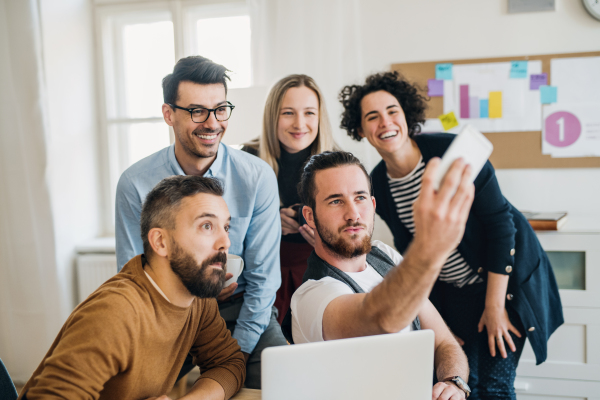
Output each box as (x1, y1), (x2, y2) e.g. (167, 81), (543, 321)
(298, 151), (371, 210)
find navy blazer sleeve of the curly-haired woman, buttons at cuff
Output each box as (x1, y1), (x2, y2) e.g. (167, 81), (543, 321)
(472, 161), (516, 275)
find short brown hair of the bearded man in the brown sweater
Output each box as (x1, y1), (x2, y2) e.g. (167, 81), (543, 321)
(140, 175), (223, 256)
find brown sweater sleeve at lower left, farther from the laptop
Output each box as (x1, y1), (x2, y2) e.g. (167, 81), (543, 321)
(26, 292), (139, 400)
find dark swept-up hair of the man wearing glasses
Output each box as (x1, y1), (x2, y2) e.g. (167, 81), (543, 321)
(163, 56), (231, 104)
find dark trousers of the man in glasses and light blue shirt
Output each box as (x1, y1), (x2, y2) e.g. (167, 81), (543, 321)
(177, 297), (287, 389)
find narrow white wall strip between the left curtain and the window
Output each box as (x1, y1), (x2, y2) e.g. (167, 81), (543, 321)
(39, 0), (101, 318)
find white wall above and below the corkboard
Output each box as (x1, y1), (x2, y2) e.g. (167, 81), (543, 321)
(357, 0), (600, 239)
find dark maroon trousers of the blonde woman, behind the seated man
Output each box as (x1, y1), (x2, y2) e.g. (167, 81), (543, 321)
(274, 240), (313, 324)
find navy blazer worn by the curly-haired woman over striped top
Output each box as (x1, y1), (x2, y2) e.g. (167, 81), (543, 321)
(371, 133), (564, 364)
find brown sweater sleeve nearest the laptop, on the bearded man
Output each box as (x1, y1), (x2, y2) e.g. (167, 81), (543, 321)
(191, 299), (246, 399)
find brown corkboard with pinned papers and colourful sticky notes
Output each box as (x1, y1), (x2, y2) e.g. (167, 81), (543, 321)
(392, 51), (600, 168)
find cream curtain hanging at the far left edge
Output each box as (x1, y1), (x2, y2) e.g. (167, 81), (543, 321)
(0, 0), (63, 382)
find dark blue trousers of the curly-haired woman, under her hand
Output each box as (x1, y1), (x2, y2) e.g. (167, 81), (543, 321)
(430, 281), (526, 400)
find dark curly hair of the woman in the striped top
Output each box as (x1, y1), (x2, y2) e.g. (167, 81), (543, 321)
(338, 71), (429, 141)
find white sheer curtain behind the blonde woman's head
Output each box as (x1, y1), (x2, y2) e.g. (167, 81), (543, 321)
(247, 0), (373, 167)
